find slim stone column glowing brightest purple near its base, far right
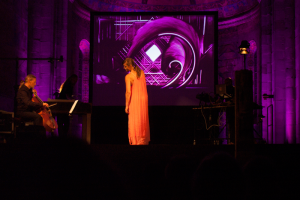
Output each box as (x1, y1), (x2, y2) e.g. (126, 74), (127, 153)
(284, 0), (296, 143)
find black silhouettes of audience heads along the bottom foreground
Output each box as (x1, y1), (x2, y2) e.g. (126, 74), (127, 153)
(0, 137), (299, 200)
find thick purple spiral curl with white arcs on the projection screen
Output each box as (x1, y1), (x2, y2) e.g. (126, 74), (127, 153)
(127, 17), (202, 87)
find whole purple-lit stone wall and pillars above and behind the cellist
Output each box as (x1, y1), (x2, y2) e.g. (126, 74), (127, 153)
(0, 0), (68, 108)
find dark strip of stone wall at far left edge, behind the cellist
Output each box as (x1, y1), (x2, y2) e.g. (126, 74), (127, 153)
(0, 0), (28, 111)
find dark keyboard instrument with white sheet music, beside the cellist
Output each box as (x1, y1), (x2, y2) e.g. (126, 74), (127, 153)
(45, 99), (92, 144)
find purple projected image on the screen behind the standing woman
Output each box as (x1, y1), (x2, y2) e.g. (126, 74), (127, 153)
(93, 13), (215, 105)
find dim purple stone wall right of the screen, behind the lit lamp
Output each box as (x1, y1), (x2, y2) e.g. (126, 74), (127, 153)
(218, 7), (262, 138)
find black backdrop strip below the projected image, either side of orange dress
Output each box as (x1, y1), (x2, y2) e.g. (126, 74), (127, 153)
(91, 106), (225, 144)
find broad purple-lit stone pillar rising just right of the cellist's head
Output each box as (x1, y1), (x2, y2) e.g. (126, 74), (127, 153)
(27, 0), (55, 101)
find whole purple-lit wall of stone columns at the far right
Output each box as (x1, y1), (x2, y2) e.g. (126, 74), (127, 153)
(261, 0), (299, 144)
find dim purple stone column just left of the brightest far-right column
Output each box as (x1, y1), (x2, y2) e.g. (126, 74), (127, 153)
(272, 0), (286, 144)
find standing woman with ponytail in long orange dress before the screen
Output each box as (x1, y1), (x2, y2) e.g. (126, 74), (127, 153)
(123, 58), (150, 145)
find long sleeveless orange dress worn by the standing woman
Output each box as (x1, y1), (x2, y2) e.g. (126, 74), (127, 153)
(128, 72), (150, 145)
